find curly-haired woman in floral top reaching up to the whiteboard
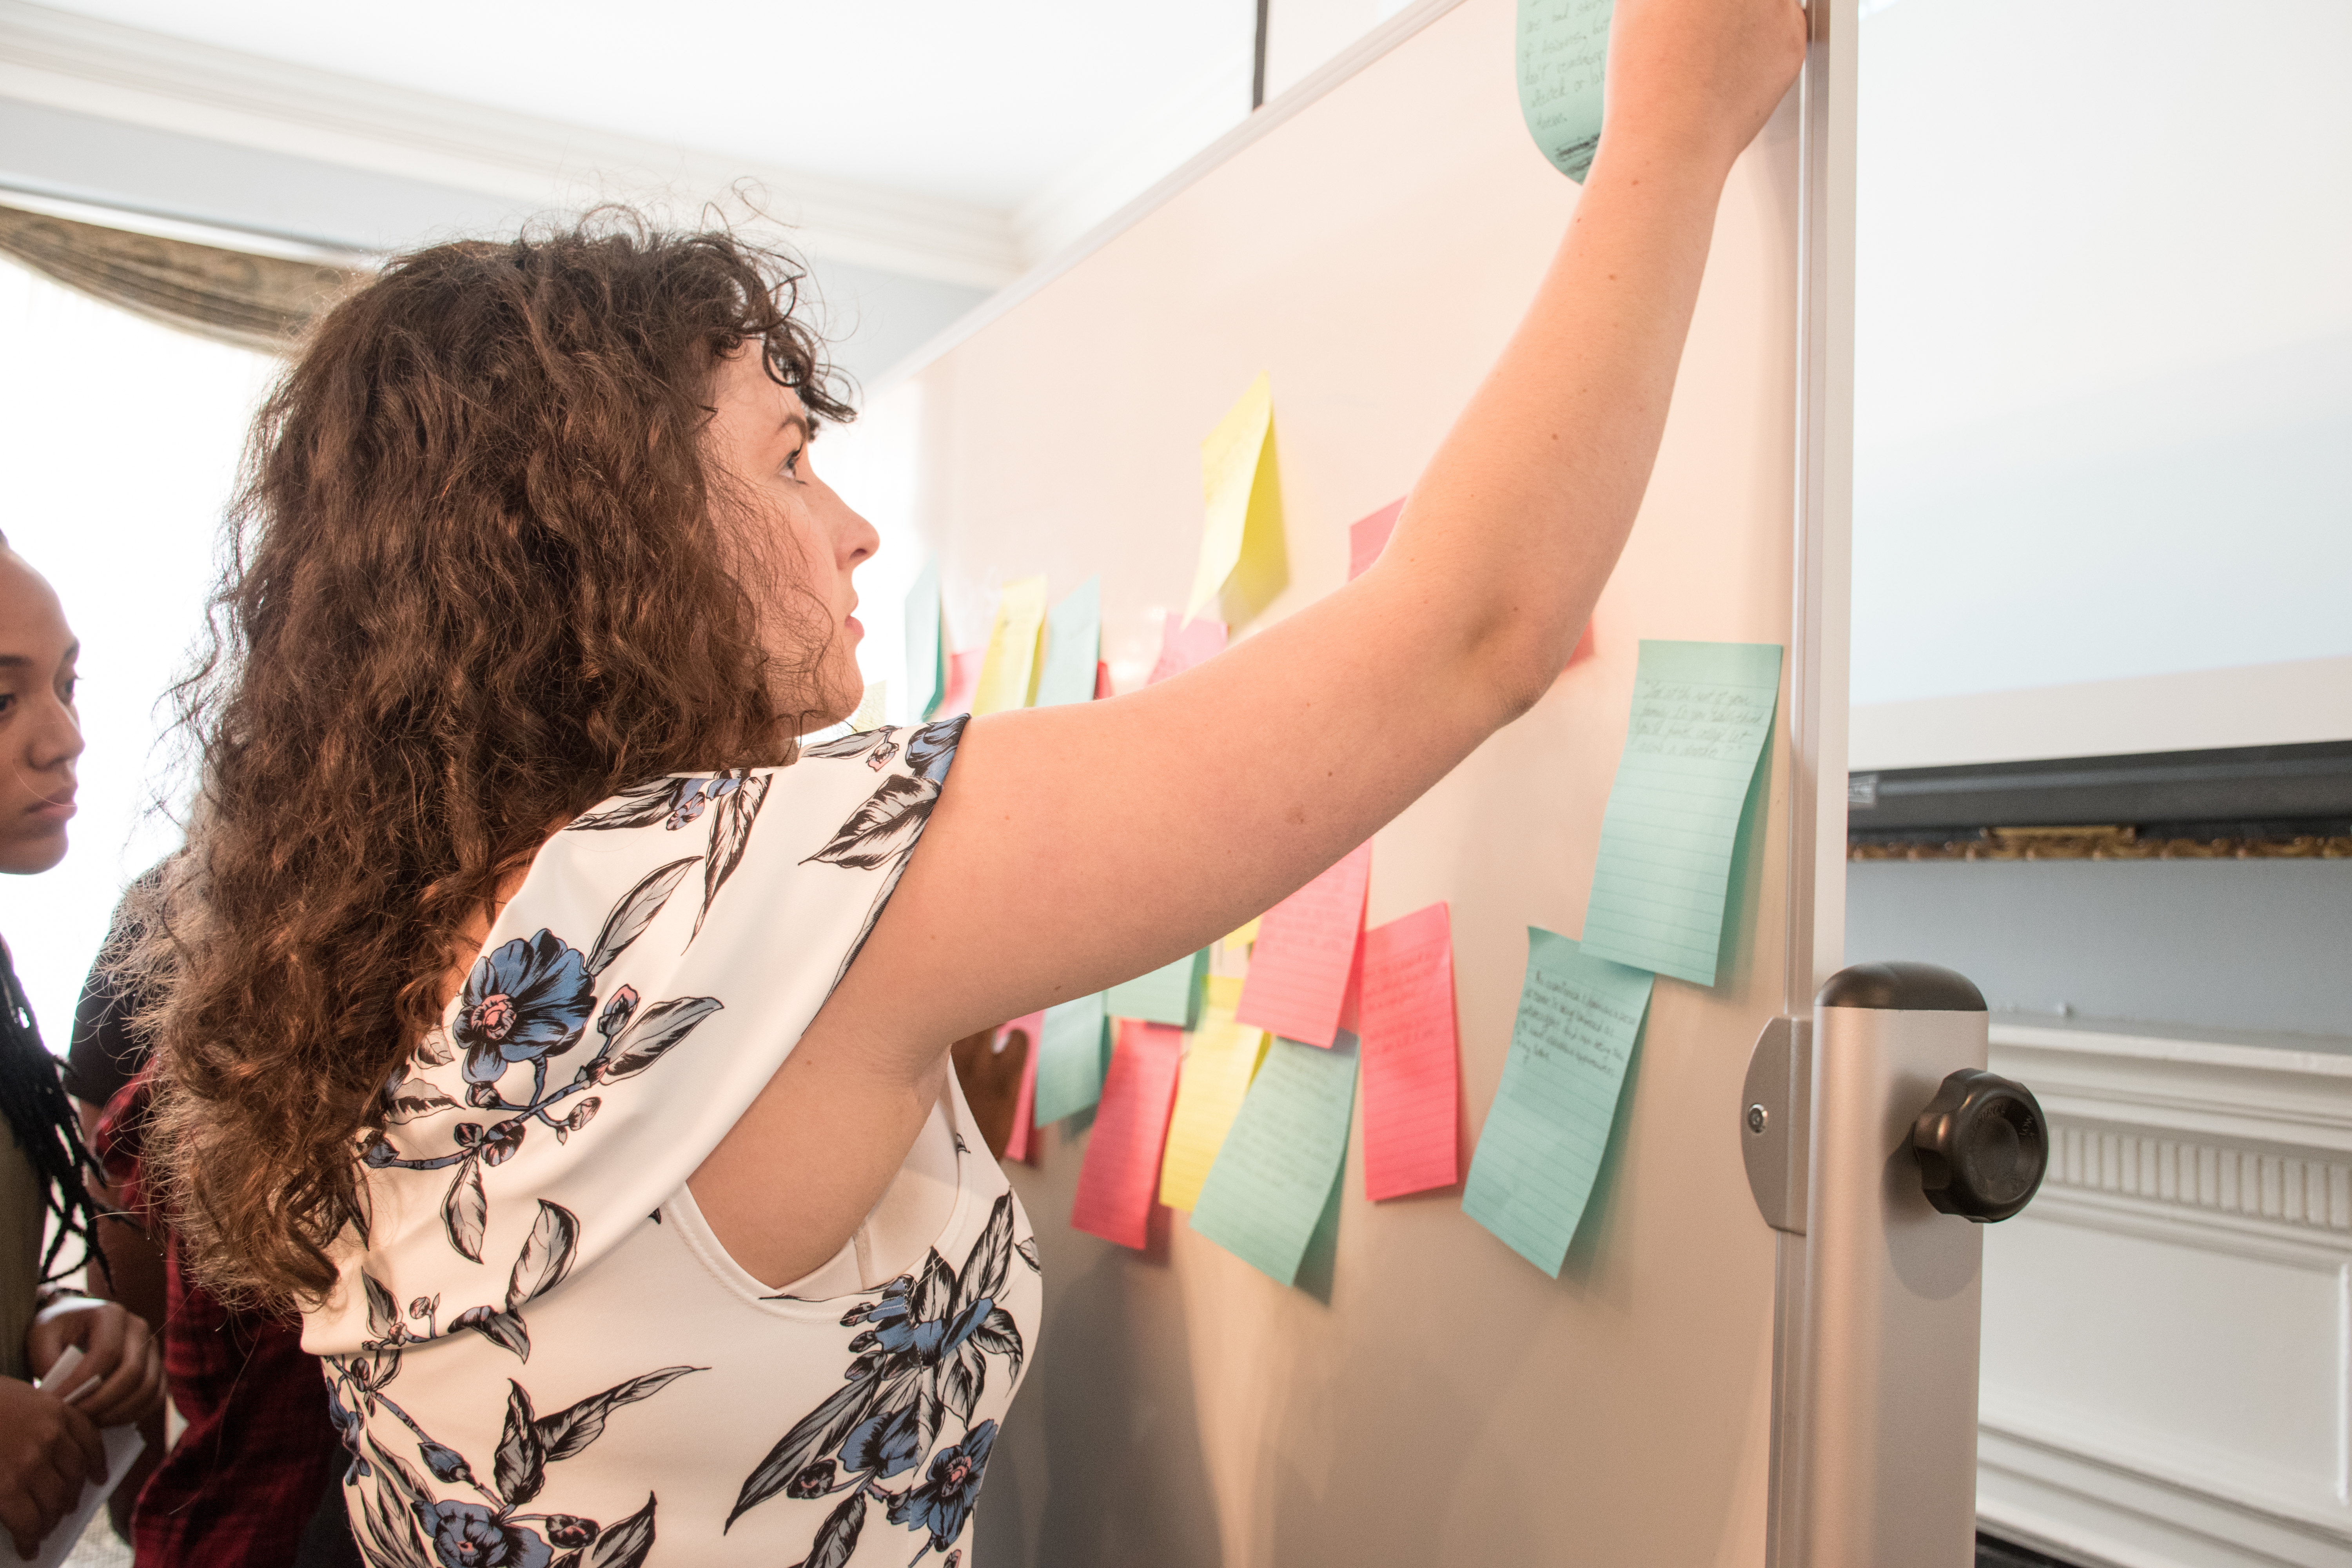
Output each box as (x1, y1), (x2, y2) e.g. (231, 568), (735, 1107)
(143, 0), (1804, 1568)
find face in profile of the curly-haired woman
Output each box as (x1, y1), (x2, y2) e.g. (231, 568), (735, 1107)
(706, 343), (882, 729)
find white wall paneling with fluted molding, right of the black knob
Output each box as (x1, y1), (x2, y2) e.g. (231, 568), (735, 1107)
(1978, 1016), (2352, 1568)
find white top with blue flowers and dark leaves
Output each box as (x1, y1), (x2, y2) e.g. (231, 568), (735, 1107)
(303, 719), (1040, 1568)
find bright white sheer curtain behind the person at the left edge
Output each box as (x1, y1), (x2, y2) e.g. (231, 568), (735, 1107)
(0, 263), (280, 1051)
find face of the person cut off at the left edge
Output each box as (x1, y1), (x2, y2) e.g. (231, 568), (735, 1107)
(0, 545), (82, 877)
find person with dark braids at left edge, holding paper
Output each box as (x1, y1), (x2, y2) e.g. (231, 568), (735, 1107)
(0, 536), (162, 1559)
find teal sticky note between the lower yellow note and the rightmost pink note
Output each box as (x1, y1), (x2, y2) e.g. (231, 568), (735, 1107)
(1192, 1032), (1355, 1283)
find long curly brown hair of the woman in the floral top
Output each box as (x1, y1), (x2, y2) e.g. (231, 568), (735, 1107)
(129, 216), (851, 1305)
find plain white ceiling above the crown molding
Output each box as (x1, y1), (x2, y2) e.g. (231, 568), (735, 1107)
(27, 0), (1256, 212)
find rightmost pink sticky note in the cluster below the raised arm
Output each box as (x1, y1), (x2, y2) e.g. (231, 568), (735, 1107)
(1359, 903), (1461, 1203)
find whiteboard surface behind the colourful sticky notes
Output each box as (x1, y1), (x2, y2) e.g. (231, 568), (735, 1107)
(875, 0), (1844, 1568)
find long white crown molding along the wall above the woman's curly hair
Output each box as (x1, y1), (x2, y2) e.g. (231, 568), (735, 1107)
(0, 0), (1025, 289)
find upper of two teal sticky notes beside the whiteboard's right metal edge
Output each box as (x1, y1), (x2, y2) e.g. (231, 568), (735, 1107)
(1583, 642), (1780, 985)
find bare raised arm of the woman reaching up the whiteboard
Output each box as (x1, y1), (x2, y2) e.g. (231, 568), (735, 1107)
(694, 0), (1804, 1281)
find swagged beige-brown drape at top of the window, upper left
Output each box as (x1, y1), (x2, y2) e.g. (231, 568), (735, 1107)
(0, 207), (360, 355)
